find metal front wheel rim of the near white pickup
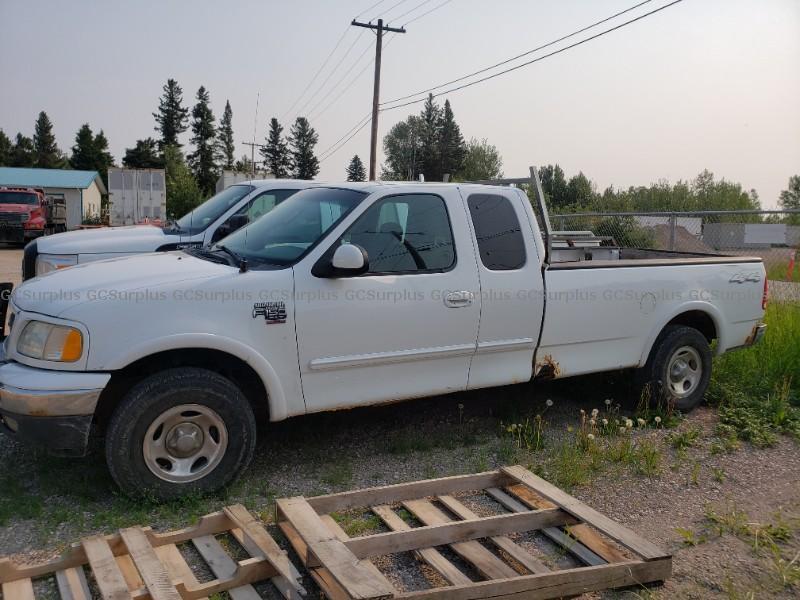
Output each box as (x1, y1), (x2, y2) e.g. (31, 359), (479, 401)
(142, 404), (228, 483)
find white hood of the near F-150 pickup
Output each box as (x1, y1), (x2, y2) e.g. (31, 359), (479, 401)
(12, 251), (231, 317)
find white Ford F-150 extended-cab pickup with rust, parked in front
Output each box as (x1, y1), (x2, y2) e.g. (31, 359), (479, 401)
(0, 171), (766, 498)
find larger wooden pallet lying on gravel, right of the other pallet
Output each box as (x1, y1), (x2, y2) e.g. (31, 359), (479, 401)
(277, 466), (672, 600)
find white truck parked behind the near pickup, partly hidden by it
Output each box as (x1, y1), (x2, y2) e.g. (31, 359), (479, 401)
(22, 179), (314, 281)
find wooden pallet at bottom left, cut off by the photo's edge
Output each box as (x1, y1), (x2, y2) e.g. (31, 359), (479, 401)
(0, 504), (305, 600)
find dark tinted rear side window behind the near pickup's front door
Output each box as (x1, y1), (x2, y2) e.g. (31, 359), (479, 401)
(467, 194), (525, 271)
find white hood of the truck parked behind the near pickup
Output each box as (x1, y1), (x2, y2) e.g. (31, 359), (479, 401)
(36, 225), (183, 254)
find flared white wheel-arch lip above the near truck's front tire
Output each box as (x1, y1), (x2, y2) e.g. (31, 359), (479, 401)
(98, 333), (289, 421)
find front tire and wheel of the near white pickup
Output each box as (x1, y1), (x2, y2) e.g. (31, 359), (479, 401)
(105, 368), (256, 500)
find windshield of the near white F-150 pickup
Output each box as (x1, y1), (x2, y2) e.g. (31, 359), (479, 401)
(220, 188), (367, 266)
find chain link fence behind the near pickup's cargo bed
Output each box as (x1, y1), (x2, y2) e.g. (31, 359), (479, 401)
(550, 210), (800, 300)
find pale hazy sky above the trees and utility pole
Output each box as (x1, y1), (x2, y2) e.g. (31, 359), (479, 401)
(0, 0), (800, 208)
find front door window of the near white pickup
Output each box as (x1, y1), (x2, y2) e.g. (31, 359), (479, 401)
(341, 194), (455, 273)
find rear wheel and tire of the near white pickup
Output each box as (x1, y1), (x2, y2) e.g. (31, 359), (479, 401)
(636, 325), (711, 412)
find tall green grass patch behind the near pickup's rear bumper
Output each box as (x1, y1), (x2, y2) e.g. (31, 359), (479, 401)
(707, 304), (800, 447)
